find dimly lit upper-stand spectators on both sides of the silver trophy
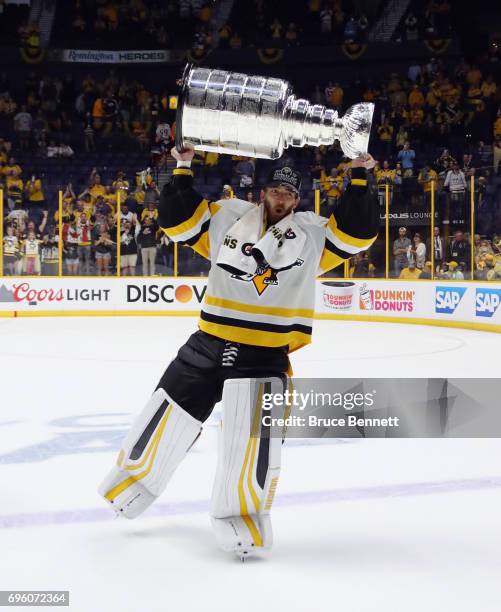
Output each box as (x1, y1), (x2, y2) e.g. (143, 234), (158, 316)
(0, 51), (501, 165)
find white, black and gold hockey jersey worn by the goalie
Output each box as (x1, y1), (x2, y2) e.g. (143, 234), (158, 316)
(159, 168), (379, 352)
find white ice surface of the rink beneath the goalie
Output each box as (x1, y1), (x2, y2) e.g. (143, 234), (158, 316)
(0, 317), (501, 612)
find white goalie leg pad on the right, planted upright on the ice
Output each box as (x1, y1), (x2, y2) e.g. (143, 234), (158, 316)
(211, 378), (286, 558)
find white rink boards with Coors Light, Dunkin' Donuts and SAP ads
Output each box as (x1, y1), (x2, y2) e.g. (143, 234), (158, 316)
(0, 277), (501, 332)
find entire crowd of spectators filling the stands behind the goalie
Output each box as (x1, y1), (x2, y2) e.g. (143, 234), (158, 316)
(0, 33), (501, 277)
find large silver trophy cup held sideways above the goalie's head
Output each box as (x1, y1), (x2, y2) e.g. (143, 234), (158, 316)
(176, 65), (374, 159)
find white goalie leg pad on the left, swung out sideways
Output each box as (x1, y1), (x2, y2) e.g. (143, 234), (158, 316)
(98, 389), (202, 518)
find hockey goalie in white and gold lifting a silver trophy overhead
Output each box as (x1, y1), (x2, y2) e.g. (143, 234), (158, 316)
(99, 148), (379, 558)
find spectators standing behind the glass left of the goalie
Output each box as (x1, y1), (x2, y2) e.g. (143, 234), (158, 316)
(0, 141), (216, 276)
